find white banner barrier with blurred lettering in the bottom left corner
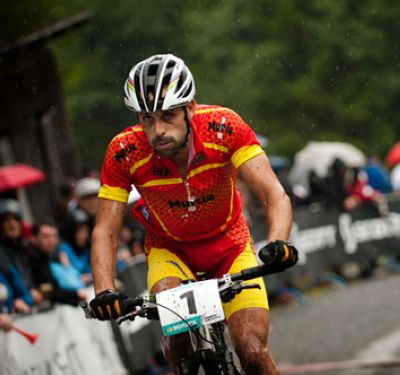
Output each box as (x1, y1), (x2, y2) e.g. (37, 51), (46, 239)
(0, 305), (128, 375)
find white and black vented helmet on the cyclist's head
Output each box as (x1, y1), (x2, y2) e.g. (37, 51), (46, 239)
(124, 54), (196, 112)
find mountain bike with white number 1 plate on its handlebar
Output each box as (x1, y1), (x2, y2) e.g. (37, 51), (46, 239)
(81, 265), (290, 375)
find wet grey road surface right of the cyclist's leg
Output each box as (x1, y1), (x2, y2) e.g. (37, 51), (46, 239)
(270, 270), (400, 375)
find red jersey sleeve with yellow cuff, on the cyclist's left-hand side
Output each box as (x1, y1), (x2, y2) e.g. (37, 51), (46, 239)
(98, 136), (133, 203)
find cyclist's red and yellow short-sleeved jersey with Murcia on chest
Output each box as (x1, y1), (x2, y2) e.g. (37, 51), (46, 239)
(99, 105), (263, 242)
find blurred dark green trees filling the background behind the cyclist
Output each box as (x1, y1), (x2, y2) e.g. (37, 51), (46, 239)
(1, 0), (400, 165)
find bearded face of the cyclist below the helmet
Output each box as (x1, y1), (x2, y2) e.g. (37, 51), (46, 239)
(139, 104), (196, 157)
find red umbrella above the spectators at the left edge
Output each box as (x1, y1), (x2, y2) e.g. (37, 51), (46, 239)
(0, 164), (46, 192)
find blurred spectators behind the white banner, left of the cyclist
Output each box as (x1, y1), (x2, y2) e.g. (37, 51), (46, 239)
(0, 173), (144, 331)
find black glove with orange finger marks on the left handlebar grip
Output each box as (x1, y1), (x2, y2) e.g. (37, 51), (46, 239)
(90, 289), (128, 320)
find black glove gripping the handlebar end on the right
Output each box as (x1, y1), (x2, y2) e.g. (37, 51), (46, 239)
(258, 240), (299, 272)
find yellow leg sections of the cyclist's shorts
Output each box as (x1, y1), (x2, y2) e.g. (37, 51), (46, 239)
(147, 243), (269, 319)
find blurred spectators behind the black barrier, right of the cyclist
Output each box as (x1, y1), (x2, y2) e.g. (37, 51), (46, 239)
(238, 143), (400, 225)
